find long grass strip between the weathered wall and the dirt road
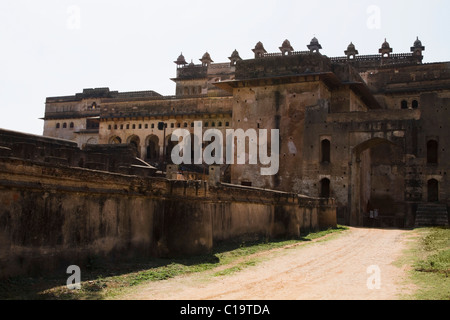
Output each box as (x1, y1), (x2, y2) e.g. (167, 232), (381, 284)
(0, 226), (348, 300)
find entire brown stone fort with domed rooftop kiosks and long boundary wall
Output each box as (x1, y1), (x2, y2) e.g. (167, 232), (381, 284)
(0, 38), (450, 277)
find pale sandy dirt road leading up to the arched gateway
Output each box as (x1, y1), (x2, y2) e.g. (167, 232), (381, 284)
(121, 228), (411, 300)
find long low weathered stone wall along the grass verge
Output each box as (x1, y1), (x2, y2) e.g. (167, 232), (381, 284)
(0, 149), (336, 278)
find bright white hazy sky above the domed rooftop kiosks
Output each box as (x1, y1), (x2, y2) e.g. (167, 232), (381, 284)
(0, 0), (450, 134)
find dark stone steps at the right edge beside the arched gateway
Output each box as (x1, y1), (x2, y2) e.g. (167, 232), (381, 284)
(415, 203), (449, 228)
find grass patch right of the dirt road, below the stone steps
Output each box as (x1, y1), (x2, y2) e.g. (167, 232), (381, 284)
(406, 227), (450, 300)
